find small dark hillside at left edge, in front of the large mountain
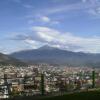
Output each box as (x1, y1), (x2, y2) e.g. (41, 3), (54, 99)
(0, 53), (27, 66)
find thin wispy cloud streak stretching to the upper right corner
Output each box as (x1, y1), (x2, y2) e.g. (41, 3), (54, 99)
(31, 0), (100, 17)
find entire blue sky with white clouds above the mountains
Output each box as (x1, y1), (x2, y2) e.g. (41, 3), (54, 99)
(0, 0), (100, 54)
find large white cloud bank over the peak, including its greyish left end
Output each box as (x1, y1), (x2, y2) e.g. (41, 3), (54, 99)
(13, 26), (100, 53)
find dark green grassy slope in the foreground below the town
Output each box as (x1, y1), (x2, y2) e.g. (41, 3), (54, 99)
(7, 91), (100, 100)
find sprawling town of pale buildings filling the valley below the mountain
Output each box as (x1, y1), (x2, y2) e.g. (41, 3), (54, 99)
(0, 64), (100, 98)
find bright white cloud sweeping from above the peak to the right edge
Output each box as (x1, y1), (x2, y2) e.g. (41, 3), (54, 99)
(30, 26), (100, 52)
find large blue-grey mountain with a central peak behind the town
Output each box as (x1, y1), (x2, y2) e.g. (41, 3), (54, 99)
(10, 45), (100, 67)
